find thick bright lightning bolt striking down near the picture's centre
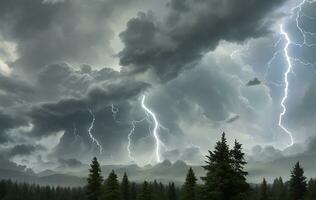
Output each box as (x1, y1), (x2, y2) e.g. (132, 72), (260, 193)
(141, 95), (164, 162)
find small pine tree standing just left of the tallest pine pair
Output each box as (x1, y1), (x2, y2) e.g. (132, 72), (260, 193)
(182, 167), (197, 200)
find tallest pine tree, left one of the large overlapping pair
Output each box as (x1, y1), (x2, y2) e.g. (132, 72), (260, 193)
(202, 133), (235, 200)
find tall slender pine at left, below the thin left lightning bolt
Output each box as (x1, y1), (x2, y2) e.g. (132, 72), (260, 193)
(86, 157), (103, 200)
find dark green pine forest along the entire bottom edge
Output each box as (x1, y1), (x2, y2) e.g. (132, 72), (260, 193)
(0, 133), (316, 200)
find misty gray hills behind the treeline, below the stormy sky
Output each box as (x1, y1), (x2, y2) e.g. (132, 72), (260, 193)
(0, 155), (316, 186)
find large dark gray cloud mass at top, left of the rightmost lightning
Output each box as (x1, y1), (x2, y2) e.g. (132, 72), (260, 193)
(119, 0), (284, 80)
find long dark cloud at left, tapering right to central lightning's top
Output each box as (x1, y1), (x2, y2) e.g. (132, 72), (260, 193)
(29, 77), (148, 139)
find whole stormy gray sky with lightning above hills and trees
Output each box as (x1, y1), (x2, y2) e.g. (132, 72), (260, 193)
(0, 0), (316, 171)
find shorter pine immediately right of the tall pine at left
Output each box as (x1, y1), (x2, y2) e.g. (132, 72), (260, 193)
(101, 170), (120, 200)
